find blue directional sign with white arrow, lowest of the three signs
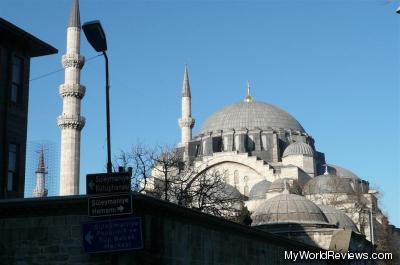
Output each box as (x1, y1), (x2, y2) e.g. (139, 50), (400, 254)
(82, 217), (143, 253)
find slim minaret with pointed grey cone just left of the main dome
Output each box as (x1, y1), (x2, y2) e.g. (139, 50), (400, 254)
(179, 65), (194, 146)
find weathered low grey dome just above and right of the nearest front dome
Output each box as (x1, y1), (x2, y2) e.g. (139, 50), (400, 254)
(303, 174), (355, 195)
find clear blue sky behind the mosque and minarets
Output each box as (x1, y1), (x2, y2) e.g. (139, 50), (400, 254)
(0, 0), (400, 226)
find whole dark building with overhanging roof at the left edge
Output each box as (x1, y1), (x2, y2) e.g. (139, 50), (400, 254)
(0, 18), (57, 199)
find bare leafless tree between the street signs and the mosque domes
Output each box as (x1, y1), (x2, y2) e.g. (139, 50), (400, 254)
(118, 145), (243, 218)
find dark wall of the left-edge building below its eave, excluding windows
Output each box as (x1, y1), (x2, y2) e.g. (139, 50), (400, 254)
(0, 38), (30, 198)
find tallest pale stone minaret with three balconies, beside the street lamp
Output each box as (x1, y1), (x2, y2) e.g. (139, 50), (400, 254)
(58, 0), (85, 196)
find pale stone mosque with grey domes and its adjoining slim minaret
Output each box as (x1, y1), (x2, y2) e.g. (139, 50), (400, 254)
(147, 64), (400, 251)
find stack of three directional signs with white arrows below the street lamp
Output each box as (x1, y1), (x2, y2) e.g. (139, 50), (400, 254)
(82, 172), (143, 253)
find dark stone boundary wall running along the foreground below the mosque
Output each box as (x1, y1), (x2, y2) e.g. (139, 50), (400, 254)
(0, 195), (332, 265)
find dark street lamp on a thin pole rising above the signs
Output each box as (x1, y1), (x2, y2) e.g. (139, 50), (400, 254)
(82, 20), (112, 173)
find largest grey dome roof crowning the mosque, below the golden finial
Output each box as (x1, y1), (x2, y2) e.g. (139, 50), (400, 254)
(198, 101), (305, 134)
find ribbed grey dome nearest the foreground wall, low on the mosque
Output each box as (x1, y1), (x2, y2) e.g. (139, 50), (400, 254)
(252, 194), (328, 225)
